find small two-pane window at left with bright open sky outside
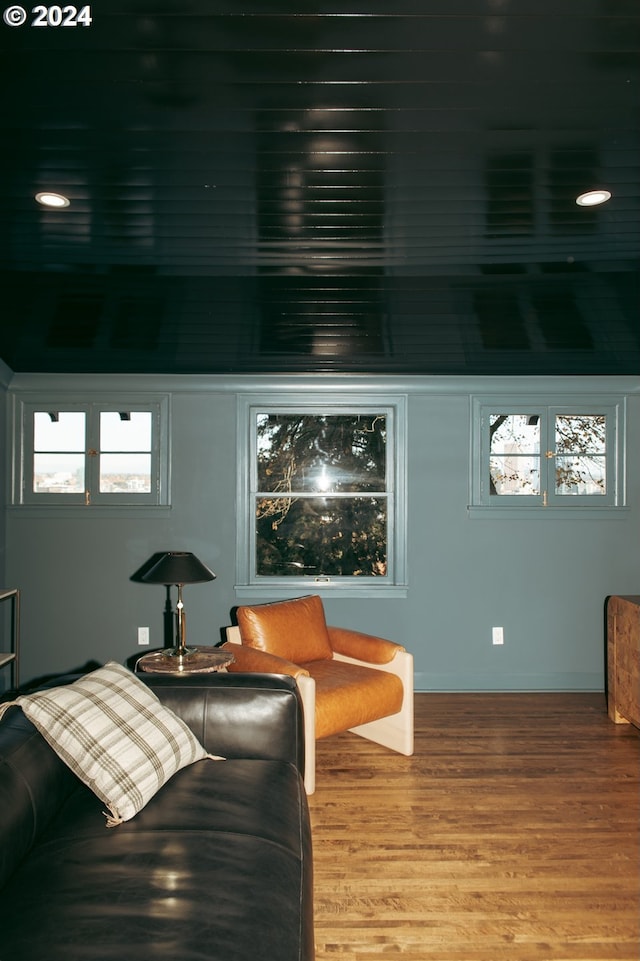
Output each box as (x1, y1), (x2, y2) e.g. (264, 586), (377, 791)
(20, 402), (166, 507)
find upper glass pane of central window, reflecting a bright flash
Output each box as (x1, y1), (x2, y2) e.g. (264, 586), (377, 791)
(256, 413), (387, 493)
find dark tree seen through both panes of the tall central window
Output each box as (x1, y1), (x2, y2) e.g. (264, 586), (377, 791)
(255, 412), (389, 577)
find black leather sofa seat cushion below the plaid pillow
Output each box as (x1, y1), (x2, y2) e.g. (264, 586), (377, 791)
(0, 758), (313, 961)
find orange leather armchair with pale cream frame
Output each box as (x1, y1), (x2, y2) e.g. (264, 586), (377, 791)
(224, 594), (413, 794)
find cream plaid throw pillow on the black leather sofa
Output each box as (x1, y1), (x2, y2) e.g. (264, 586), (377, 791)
(2, 661), (221, 827)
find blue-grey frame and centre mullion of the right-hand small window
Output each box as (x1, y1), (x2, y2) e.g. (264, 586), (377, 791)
(468, 394), (625, 517)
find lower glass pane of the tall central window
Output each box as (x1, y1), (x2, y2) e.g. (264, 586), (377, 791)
(256, 497), (387, 577)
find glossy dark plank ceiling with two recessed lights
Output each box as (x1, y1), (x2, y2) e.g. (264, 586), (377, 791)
(0, 0), (640, 374)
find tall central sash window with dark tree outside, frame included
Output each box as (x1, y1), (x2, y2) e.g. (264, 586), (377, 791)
(239, 403), (404, 590)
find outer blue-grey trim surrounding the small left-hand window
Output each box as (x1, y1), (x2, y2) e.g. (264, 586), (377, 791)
(11, 392), (170, 516)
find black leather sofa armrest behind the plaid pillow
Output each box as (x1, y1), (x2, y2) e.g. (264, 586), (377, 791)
(144, 672), (304, 774)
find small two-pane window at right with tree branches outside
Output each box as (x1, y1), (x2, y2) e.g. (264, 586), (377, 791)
(473, 402), (621, 508)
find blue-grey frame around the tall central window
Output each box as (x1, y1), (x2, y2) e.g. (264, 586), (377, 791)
(235, 392), (407, 598)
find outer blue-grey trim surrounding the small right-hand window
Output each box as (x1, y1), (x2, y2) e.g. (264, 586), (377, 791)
(467, 393), (627, 519)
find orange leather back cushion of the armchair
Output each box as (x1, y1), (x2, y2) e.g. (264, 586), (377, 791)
(236, 594), (333, 664)
